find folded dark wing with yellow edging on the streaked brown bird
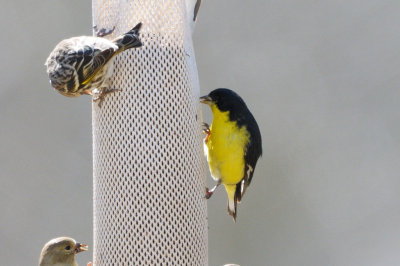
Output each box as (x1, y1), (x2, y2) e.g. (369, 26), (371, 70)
(76, 45), (115, 86)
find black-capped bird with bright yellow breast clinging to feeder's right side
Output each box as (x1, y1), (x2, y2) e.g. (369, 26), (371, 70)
(200, 89), (262, 220)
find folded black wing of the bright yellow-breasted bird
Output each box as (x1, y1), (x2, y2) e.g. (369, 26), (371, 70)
(236, 112), (262, 202)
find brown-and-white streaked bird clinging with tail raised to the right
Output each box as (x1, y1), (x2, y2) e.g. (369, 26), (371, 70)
(45, 23), (142, 103)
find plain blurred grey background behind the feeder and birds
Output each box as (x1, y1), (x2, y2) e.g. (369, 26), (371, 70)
(0, 0), (400, 266)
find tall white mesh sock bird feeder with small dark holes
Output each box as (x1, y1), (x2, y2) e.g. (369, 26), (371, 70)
(92, 0), (208, 266)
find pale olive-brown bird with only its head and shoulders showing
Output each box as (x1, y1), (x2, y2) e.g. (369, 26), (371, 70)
(39, 237), (88, 266)
